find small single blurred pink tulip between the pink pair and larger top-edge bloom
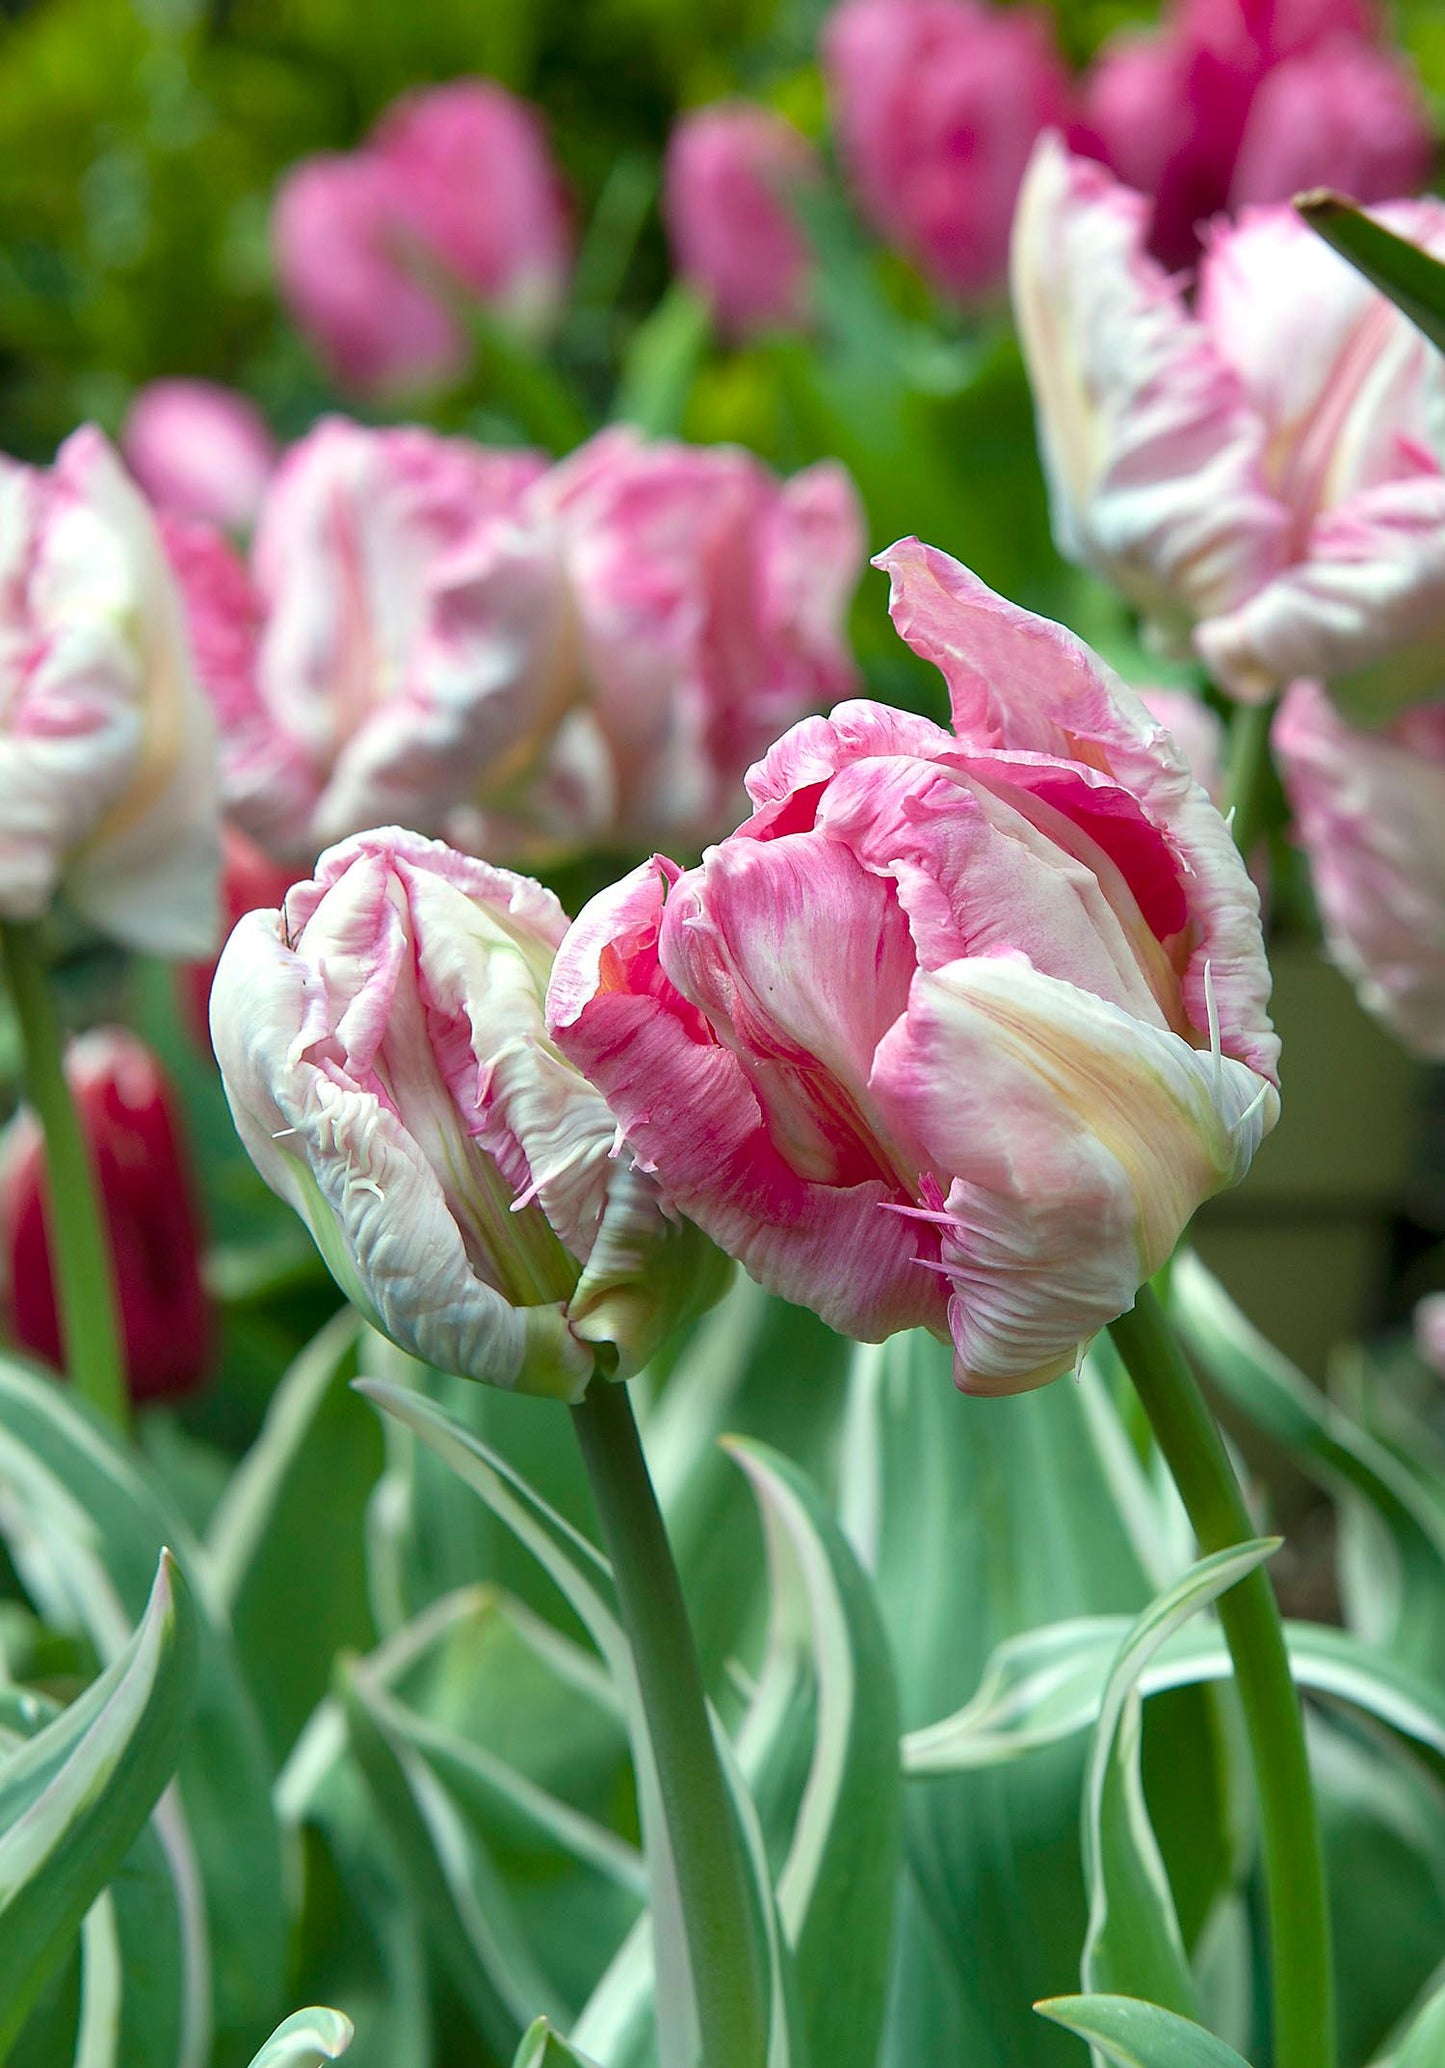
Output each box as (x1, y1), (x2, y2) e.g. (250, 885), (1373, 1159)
(664, 101), (821, 337)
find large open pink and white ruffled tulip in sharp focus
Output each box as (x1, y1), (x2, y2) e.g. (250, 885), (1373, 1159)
(548, 540), (1278, 1392)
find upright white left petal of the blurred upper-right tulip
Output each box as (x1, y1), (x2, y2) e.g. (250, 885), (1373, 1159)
(1013, 136), (1286, 639)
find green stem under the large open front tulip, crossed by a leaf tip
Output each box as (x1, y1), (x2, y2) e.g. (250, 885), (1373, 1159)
(1110, 1286), (1335, 2068)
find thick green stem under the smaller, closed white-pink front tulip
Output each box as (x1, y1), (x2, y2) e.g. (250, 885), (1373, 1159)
(573, 1377), (767, 2068)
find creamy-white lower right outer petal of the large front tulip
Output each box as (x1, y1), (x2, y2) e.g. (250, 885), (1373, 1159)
(870, 957), (1278, 1394)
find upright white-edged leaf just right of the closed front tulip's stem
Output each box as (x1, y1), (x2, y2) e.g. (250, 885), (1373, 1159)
(728, 1439), (903, 2068)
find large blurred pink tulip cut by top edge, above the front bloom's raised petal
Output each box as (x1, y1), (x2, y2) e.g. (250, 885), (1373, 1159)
(823, 0), (1069, 300)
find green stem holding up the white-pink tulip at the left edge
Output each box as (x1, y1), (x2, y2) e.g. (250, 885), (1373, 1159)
(0, 920), (130, 1431)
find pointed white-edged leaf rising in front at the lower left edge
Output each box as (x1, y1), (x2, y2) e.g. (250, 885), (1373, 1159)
(0, 1551), (196, 2058)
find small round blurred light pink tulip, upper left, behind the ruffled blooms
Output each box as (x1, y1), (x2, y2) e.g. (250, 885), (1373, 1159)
(120, 381), (277, 531)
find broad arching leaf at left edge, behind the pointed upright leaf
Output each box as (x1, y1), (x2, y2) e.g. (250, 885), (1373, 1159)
(0, 1357), (287, 2058)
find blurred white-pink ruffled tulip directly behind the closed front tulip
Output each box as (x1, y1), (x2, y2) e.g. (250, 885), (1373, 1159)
(170, 418), (568, 864)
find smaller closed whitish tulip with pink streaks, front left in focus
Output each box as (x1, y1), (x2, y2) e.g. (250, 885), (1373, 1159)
(211, 829), (726, 1400)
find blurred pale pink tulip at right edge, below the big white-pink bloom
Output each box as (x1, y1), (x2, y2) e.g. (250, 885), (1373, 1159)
(1273, 682), (1445, 1059)
